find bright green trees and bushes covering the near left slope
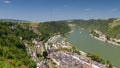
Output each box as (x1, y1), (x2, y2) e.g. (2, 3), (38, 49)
(0, 22), (36, 68)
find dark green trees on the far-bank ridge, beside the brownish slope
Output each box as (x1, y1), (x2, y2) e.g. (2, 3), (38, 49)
(70, 18), (114, 31)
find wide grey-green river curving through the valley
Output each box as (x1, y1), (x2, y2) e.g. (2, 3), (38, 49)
(67, 29), (120, 68)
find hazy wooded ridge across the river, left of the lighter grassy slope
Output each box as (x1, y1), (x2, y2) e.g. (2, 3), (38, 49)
(57, 18), (116, 29)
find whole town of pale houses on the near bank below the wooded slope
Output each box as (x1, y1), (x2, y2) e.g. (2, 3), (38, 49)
(20, 35), (107, 68)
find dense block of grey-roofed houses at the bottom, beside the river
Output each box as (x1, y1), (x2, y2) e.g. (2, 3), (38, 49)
(52, 51), (107, 68)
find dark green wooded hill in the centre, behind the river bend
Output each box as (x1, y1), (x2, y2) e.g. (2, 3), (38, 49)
(39, 22), (70, 41)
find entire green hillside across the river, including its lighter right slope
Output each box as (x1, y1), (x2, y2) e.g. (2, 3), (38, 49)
(64, 18), (120, 39)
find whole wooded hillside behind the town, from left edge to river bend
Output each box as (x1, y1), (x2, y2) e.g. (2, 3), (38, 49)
(0, 21), (70, 68)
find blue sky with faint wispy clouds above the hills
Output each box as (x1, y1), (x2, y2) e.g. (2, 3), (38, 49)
(0, 0), (120, 22)
